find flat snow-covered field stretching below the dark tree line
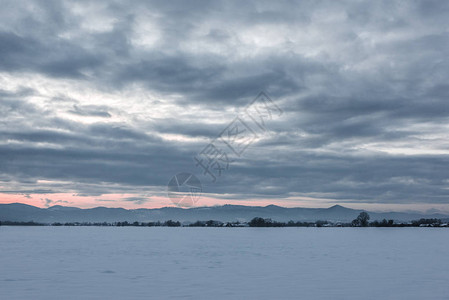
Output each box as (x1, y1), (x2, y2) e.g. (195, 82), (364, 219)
(0, 226), (449, 299)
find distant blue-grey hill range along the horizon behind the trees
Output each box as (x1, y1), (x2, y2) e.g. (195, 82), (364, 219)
(0, 203), (449, 223)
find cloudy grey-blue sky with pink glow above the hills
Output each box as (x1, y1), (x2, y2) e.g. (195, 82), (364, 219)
(0, 0), (449, 212)
